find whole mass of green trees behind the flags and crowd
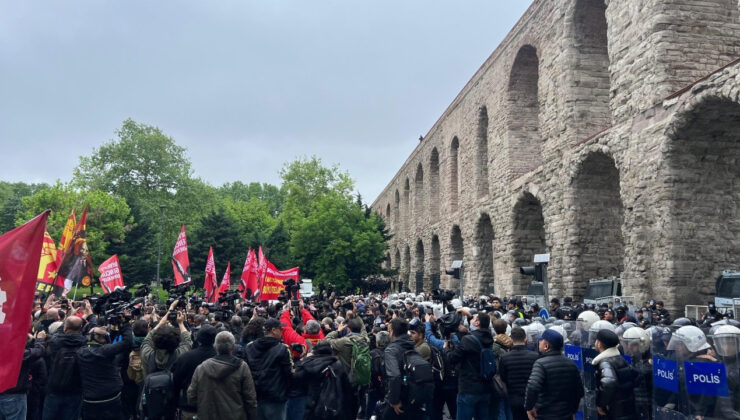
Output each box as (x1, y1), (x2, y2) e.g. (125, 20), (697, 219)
(0, 119), (388, 287)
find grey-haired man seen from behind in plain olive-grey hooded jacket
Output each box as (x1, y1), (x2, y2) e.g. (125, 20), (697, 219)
(188, 331), (257, 420)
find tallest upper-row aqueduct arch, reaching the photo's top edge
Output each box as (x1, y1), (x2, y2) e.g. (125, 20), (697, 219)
(571, 0), (611, 139)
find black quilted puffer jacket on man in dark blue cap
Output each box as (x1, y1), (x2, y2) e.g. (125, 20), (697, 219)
(524, 351), (583, 419)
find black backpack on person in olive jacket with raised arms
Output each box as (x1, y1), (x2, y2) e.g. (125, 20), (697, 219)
(141, 352), (175, 419)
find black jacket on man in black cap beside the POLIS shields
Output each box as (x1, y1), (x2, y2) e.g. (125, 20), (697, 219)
(596, 354), (636, 420)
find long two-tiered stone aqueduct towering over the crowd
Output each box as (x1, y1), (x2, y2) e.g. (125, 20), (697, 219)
(372, 0), (740, 310)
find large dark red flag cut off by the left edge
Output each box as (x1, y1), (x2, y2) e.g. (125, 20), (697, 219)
(0, 210), (49, 392)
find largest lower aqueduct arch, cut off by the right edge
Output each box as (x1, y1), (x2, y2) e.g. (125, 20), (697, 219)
(661, 96), (740, 309)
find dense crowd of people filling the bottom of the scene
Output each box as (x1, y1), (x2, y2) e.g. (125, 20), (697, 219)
(0, 290), (740, 420)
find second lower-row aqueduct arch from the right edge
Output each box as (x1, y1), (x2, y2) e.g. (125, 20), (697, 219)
(572, 151), (624, 298)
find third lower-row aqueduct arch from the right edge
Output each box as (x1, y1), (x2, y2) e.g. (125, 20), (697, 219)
(512, 192), (547, 294)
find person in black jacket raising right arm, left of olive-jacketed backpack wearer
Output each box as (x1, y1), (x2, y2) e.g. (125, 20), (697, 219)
(77, 314), (134, 420)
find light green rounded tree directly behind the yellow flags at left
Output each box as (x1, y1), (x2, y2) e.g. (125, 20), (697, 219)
(16, 182), (134, 264)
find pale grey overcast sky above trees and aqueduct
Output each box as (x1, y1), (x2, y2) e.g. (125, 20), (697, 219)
(0, 0), (531, 202)
